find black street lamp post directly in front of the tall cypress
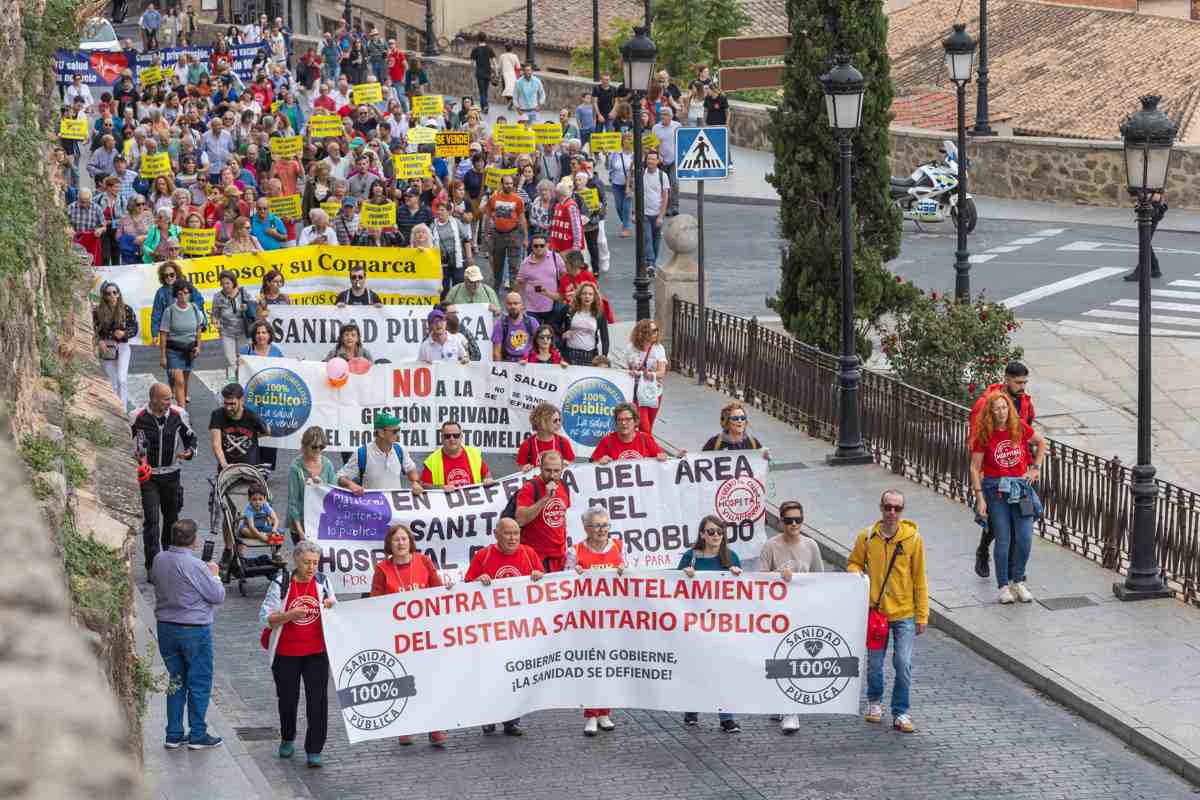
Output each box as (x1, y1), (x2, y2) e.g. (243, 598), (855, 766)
(821, 53), (871, 467)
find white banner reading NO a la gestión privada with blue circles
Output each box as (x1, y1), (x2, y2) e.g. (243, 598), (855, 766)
(238, 354), (634, 456)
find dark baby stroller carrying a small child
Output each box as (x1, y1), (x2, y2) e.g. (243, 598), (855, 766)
(209, 464), (284, 597)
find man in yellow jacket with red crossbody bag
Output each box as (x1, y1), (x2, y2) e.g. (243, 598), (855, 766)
(846, 489), (929, 733)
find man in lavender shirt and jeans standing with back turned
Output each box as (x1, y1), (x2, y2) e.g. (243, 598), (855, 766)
(150, 519), (224, 750)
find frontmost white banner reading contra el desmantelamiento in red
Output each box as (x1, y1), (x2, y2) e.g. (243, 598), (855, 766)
(322, 570), (866, 742)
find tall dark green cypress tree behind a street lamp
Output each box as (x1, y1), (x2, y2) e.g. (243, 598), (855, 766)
(767, 0), (917, 357)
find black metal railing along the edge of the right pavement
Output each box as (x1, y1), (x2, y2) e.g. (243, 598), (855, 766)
(671, 297), (1200, 606)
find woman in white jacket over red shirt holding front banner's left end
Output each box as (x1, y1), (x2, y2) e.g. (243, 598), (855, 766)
(258, 541), (337, 768)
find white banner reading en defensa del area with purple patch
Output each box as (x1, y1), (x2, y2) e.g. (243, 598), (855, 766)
(304, 450), (774, 591)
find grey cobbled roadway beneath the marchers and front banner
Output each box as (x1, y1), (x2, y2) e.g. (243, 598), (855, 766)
(138, 376), (1194, 800)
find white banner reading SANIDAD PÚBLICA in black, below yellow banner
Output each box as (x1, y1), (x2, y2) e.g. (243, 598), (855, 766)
(268, 302), (494, 362)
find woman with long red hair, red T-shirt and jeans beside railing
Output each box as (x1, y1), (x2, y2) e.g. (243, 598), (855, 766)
(971, 390), (1046, 604)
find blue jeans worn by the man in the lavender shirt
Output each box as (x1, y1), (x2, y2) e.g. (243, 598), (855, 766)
(158, 622), (212, 741)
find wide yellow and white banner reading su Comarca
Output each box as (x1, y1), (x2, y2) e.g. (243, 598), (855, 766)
(95, 245), (442, 344)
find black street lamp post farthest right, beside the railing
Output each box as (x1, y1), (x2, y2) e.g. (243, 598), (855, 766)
(1112, 95), (1176, 600)
